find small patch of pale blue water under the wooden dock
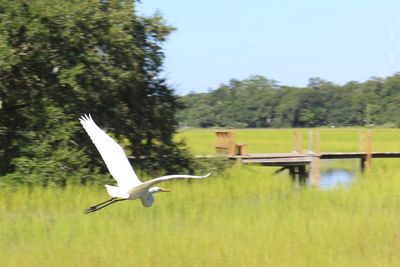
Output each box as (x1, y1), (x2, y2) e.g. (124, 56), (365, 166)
(319, 169), (354, 189)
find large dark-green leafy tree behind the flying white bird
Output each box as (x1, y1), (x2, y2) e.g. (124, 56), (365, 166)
(0, 0), (189, 184)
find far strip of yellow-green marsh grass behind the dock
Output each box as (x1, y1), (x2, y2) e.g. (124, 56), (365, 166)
(176, 128), (400, 155)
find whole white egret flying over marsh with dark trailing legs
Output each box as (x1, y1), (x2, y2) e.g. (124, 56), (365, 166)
(79, 114), (211, 214)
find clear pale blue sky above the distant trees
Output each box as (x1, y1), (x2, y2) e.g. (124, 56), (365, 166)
(137, 0), (400, 95)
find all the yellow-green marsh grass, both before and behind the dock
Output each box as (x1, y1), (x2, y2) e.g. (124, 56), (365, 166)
(0, 129), (400, 266)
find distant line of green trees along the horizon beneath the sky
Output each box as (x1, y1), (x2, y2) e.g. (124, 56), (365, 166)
(178, 73), (400, 128)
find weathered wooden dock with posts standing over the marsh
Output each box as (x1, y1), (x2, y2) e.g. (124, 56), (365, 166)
(216, 129), (400, 186)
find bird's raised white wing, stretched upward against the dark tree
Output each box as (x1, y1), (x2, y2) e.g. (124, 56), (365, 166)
(79, 114), (142, 189)
